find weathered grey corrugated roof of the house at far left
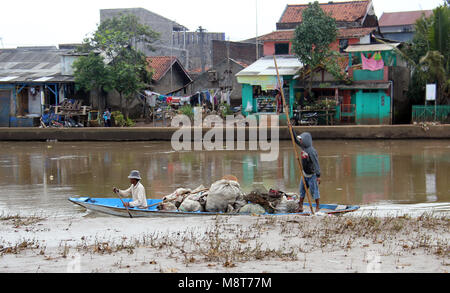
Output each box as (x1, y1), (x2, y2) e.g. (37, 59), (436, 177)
(0, 47), (74, 83)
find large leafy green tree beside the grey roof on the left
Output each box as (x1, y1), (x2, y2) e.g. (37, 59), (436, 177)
(75, 15), (159, 118)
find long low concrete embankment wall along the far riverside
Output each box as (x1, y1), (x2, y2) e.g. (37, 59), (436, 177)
(0, 125), (450, 141)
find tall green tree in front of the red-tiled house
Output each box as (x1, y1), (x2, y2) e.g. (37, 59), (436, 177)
(292, 1), (338, 96)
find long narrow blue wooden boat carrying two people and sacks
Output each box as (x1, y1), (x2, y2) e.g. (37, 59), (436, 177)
(69, 197), (359, 218)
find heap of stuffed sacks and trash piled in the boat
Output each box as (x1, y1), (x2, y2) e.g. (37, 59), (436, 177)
(158, 175), (299, 214)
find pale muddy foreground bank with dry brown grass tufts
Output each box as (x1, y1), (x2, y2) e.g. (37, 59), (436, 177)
(0, 214), (450, 273)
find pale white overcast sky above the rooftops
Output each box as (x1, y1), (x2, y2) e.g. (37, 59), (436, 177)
(0, 0), (444, 48)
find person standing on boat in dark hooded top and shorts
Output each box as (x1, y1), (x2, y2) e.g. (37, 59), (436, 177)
(292, 129), (320, 212)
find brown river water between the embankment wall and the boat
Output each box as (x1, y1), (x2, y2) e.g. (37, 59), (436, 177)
(0, 140), (450, 216)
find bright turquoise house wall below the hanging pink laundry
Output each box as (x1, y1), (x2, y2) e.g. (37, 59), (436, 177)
(352, 90), (391, 125)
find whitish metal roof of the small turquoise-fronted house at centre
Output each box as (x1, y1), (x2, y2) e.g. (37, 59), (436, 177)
(236, 56), (303, 76)
